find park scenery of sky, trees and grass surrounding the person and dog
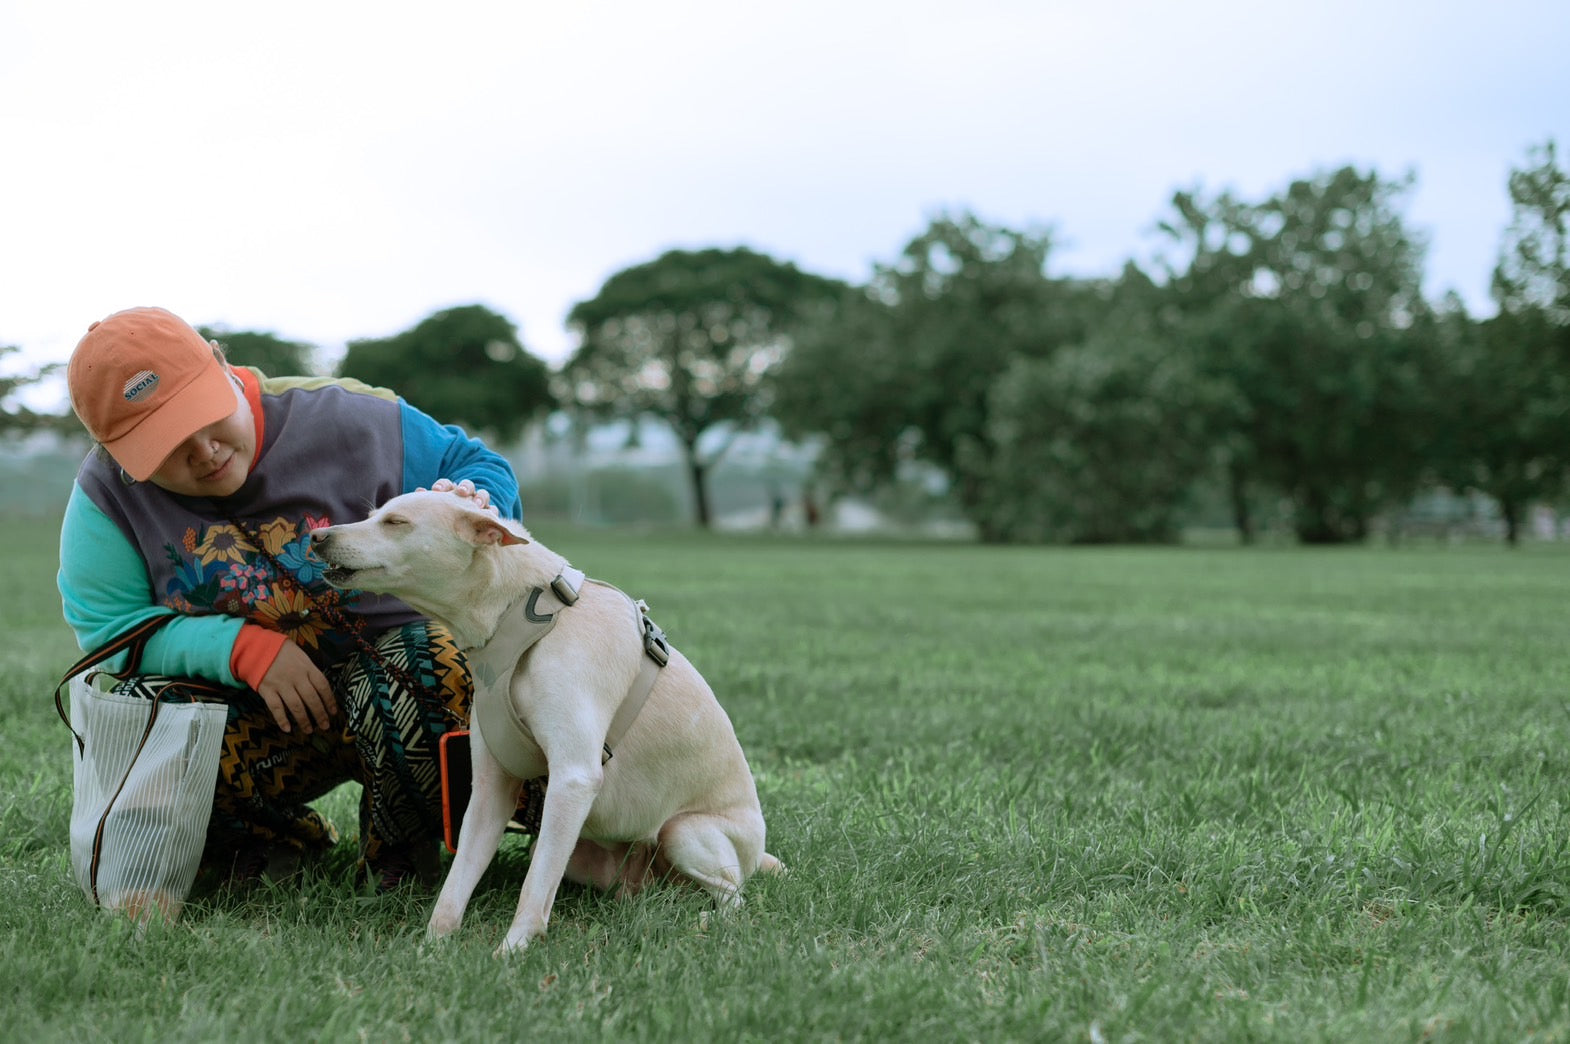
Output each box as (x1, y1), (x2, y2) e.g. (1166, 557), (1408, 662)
(0, 0), (1570, 1042)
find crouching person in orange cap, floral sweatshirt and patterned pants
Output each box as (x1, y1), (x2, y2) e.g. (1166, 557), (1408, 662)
(58, 308), (523, 892)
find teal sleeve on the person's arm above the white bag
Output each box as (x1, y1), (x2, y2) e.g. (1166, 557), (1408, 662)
(57, 487), (245, 688)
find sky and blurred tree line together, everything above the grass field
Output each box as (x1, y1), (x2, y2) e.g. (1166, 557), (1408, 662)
(0, 0), (1570, 543)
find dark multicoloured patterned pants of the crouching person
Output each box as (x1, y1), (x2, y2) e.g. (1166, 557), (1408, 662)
(204, 622), (471, 871)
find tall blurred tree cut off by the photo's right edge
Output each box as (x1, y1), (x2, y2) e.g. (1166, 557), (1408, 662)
(1441, 141), (1570, 546)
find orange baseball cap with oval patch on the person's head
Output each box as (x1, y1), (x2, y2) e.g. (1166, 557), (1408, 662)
(66, 308), (239, 482)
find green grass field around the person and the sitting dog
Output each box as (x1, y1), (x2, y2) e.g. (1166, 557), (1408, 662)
(0, 521), (1570, 1041)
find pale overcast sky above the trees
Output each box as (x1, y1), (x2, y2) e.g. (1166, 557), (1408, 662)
(0, 0), (1570, 408)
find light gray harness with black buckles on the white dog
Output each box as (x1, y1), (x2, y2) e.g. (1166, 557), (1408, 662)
(465, 565), (670, 779)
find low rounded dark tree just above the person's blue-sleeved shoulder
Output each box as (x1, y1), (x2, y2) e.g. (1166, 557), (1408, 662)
(338, 305), (554, 443)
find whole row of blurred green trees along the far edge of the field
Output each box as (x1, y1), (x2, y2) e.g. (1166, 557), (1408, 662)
(12, 141), (1570, 543)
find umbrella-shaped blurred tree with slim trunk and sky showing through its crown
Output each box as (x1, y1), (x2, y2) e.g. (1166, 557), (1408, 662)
(562, 248), (845, 526)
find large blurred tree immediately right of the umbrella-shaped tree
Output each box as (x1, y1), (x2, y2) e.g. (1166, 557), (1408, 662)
(776, 215), (1105, 540)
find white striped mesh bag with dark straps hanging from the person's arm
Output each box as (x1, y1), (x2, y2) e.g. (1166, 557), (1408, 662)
(55, 617), (228, 920)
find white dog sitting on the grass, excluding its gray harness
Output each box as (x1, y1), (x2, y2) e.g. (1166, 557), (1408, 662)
(312, 491), (780, 951)
